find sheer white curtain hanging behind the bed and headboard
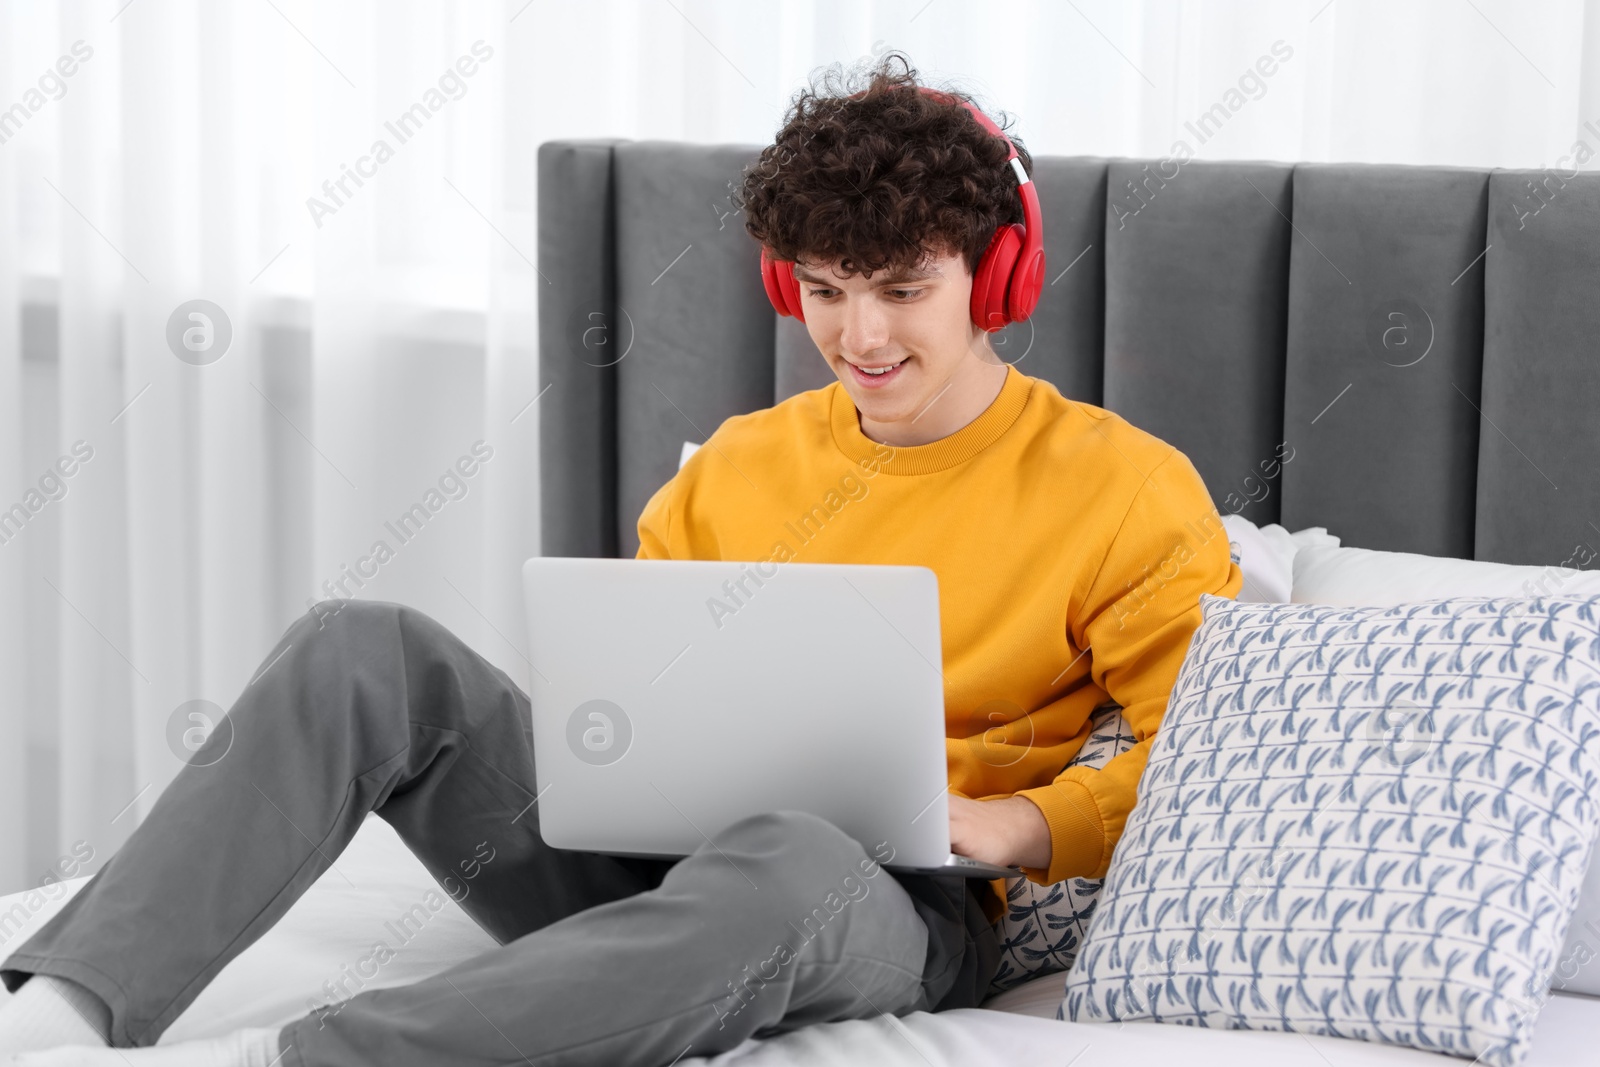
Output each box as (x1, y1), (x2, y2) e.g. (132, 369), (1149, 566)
(0, 0), (1600, 891)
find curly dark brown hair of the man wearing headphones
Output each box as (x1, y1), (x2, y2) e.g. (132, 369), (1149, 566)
(730, 51), (1034, 277)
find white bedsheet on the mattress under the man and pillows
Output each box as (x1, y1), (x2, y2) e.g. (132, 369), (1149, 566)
(0, 817), (1600, 1067)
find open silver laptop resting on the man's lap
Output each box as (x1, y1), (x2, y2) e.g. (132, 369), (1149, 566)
(523, 557), (1022, 878)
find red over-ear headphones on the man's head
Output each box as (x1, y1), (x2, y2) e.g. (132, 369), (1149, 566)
(762, 86), (1045, 333)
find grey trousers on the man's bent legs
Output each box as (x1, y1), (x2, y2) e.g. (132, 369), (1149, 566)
(0, 600), (998, 1067)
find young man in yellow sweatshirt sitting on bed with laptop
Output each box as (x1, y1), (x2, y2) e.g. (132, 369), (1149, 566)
(0, 53), (1242, 1067)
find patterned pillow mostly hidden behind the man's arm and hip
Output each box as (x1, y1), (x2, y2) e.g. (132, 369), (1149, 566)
(989, 701), (1134, 993)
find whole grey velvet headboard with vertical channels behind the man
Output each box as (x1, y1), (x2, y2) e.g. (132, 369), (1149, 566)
(539, 141), (1600, 566)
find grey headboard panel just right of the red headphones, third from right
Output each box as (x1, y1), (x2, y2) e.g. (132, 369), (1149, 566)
(1104, 160), (1293, 523)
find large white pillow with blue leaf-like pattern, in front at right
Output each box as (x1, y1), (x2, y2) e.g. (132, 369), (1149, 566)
(1058, 593), (1600, 1067)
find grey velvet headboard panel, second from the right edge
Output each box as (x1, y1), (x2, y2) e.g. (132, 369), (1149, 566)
(1283, 163), (1488, 558)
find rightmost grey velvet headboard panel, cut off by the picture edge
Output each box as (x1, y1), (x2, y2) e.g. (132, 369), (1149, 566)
(1477, 171), (1600, 566)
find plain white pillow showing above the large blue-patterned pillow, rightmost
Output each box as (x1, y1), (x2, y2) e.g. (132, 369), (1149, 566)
(1292, 547), (1600, 608)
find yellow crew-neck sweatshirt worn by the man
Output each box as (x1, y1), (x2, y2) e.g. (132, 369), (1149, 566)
(638, 366), (1243, 920)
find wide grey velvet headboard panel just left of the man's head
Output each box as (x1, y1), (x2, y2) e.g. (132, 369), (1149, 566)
(616, 141), (773, 557)
